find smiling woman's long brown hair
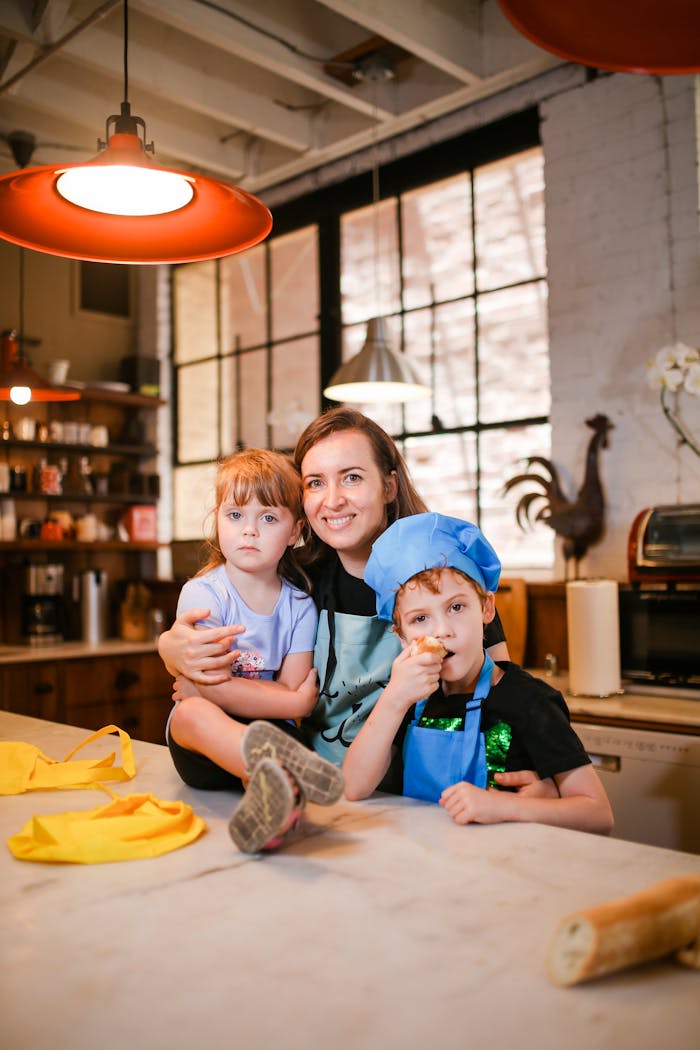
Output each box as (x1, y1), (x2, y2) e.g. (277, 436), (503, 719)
(294, 405), (428, 564)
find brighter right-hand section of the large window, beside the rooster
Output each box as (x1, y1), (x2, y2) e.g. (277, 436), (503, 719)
(341, 148), (552, 569)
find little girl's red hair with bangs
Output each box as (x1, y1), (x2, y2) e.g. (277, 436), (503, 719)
(196, 448), (310, 590)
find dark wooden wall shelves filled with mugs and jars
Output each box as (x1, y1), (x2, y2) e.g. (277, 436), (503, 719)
(0, 387), (165, 644)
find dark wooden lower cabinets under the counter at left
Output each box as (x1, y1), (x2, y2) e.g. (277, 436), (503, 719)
(0, 652), (172, 743)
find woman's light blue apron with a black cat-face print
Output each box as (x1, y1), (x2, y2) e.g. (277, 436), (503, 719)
(303, 609), (401, 765)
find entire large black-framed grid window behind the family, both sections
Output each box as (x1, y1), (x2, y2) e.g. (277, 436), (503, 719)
(174, 110), (553, 572)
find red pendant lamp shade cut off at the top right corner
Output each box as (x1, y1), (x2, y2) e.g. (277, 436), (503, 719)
(499, 0), (700, 75)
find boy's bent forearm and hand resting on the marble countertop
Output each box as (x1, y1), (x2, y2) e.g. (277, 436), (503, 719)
(440, 764), (613, 835)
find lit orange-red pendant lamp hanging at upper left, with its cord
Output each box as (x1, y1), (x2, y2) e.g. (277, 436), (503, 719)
(0, 0), (272, 264)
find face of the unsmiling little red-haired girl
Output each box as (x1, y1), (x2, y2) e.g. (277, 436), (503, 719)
(216, 499), (301, 582)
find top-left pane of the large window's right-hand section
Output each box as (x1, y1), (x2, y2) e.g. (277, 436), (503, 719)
(340, 198), (399, 324)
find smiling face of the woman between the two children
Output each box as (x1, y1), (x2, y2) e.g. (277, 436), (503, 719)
(301, 431), (398, 576)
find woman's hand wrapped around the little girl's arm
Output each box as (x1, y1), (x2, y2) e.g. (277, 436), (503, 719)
(158, 609), (246, 686)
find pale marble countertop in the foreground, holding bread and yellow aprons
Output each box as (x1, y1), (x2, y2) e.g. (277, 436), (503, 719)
(0, 712), (700, 1050)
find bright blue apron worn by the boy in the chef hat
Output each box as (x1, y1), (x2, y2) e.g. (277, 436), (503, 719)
(403, 652), (493, 802)
